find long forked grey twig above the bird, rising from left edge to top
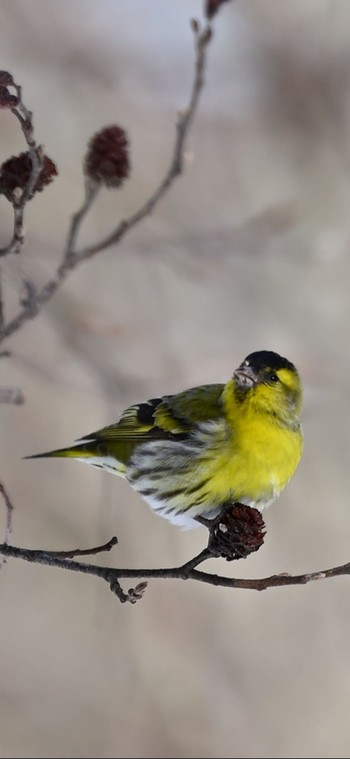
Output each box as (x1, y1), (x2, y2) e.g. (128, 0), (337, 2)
(0, 17), (212, 342)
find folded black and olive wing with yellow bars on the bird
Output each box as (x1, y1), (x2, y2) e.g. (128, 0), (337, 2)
(83, 384), (224, 443)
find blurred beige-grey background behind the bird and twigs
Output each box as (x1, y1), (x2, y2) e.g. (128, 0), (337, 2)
(0, 0), (350, 757)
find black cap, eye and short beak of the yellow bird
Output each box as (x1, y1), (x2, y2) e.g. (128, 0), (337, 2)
(233, 351), (297, 390)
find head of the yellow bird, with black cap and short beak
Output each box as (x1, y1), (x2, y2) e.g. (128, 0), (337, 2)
(233, 351), (302, 426)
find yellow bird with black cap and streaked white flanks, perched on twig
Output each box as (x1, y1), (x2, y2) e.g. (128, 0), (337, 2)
(25, 350), (303, 529)
